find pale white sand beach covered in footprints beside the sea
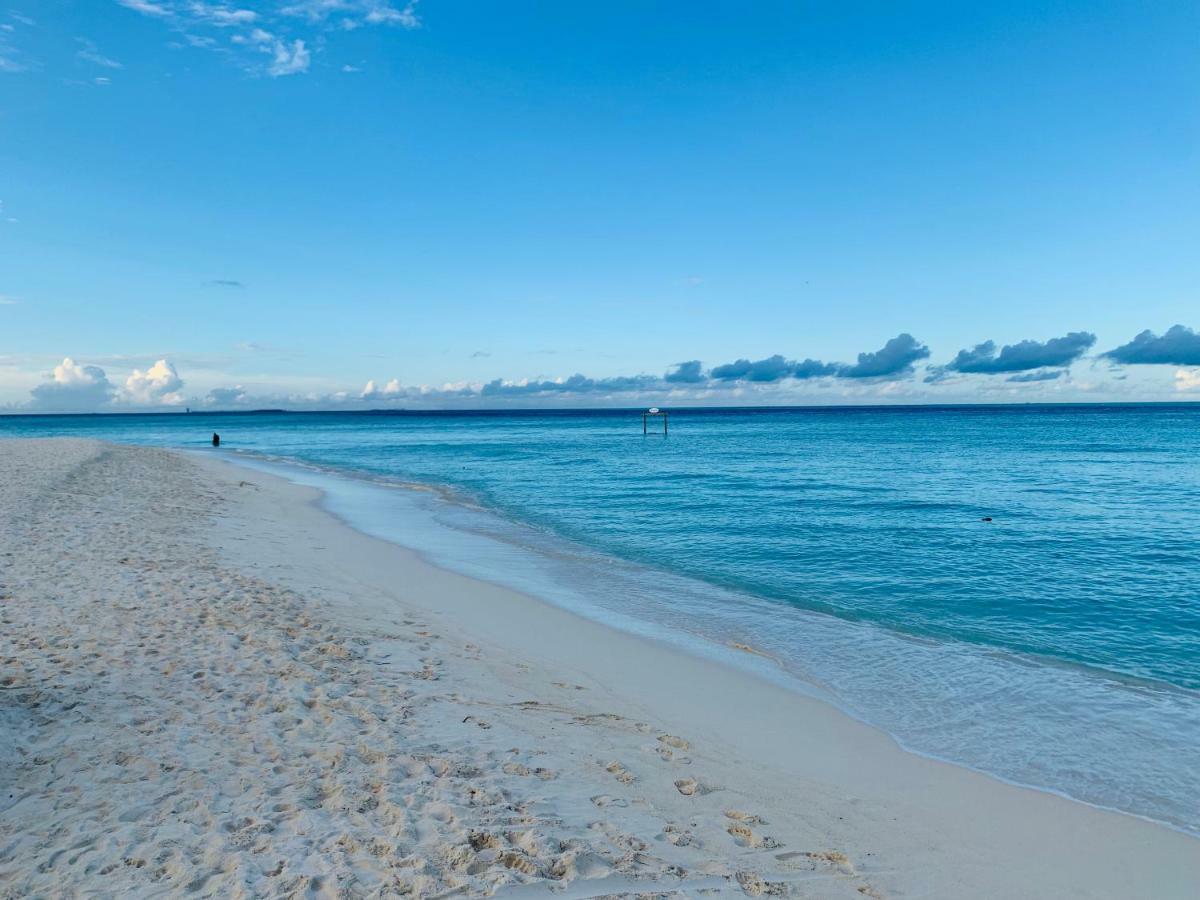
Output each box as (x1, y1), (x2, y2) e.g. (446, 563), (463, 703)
(0, 439), (1200, 898)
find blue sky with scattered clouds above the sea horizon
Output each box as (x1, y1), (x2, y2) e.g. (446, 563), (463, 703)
(0, 0), (1200, 412)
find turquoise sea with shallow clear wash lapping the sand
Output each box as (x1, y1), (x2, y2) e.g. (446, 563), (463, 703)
(0, 404), (1200, 833)
